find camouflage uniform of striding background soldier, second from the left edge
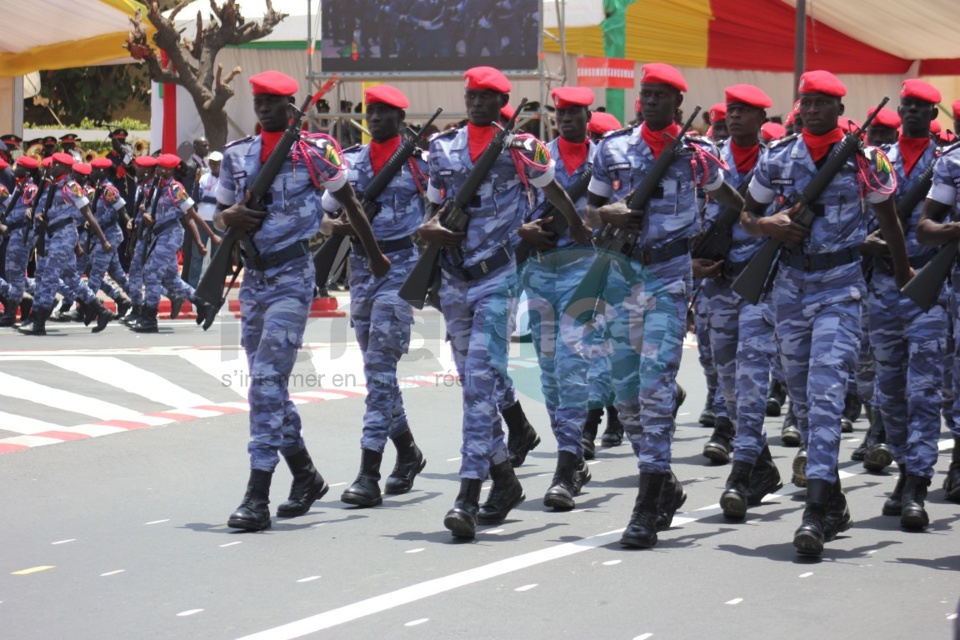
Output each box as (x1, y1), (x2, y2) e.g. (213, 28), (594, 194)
(33, 175), (97, 309)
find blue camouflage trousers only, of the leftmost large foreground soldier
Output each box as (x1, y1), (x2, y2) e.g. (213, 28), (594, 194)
(239, 256), (316, 471)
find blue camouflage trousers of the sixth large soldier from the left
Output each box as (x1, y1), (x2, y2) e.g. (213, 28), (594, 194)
(701, 279), (777, 464)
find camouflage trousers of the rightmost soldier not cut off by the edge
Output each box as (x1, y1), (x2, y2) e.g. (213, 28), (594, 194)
(868, 273), (947, 478)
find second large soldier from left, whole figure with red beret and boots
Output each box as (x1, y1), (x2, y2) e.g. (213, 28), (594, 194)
(322, 85), (427, 507)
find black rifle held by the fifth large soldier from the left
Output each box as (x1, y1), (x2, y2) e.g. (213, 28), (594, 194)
(571, 106), (700, 318)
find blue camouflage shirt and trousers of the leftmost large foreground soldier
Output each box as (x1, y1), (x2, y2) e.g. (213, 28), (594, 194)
(216, 134), (347, 472)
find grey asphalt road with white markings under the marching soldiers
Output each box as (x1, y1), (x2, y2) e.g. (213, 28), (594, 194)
(0, 314), (960, 640)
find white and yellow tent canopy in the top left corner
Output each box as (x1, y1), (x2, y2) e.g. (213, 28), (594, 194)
(0, 0), (144, 77)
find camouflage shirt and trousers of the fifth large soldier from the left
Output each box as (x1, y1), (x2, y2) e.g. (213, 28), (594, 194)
(574, 125), (723, 473)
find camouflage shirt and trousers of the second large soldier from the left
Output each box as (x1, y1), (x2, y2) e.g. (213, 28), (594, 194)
(323, 145), (427, 453)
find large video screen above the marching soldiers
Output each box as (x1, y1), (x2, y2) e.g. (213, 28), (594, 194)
(320, 0), (540, 73)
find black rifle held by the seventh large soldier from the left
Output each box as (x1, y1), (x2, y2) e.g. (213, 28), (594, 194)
(731, 96), (890, 304)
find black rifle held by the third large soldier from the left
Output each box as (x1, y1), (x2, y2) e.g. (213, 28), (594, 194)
(398, 98), (527, 309)
